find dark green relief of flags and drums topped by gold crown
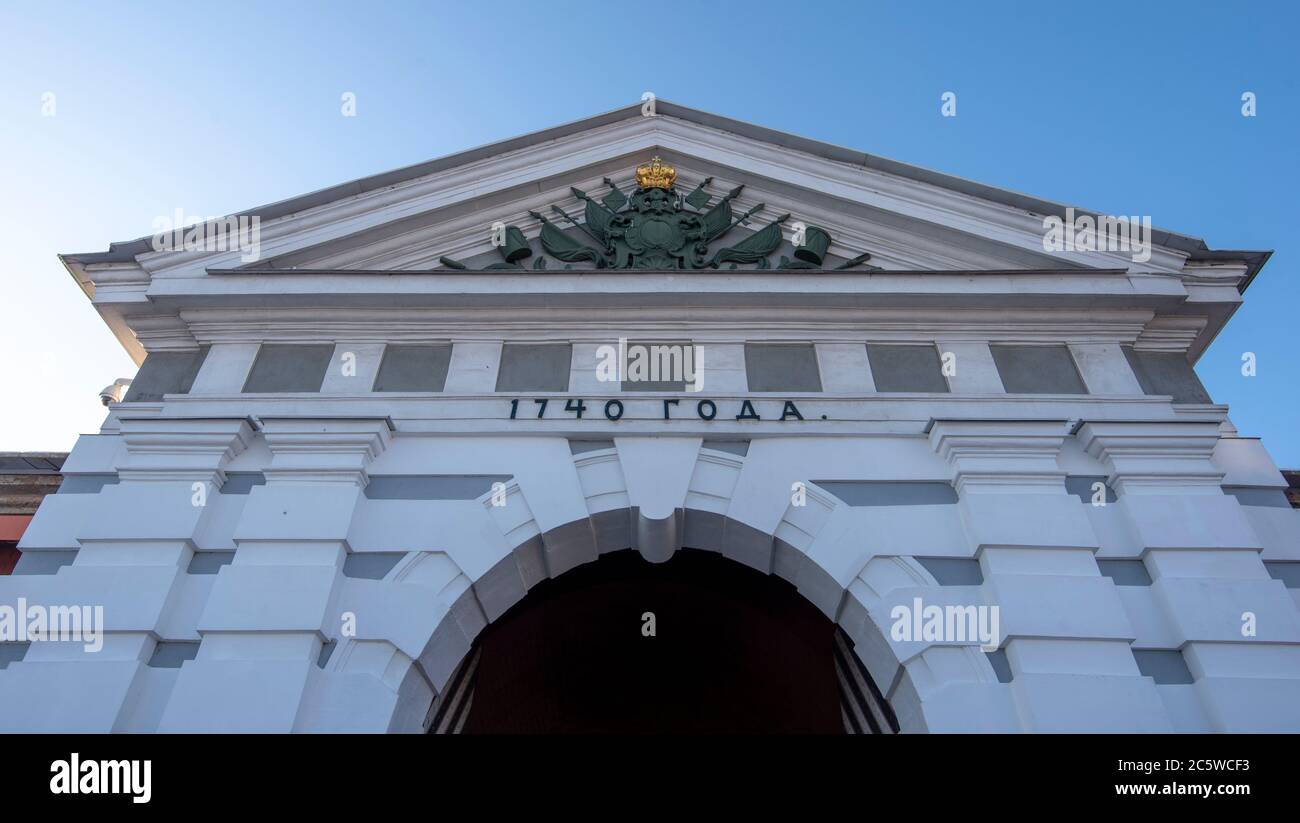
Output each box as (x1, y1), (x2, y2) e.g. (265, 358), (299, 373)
(441, 157), (875, 272)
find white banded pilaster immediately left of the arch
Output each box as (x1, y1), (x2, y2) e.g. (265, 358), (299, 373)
(161, 417), (391, 732)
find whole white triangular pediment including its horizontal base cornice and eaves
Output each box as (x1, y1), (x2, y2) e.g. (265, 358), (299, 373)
(62, 101), (1269, 359)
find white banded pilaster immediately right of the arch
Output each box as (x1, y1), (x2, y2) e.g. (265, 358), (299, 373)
(930, 421), (1169, 731)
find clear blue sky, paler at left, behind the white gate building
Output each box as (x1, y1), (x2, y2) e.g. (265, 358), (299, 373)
(0, 0), (1300, 468)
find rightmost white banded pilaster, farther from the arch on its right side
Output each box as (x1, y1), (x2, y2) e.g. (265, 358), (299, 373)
(1079, 423), (1300, 731)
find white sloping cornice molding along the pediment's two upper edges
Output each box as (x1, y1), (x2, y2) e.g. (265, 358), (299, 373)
(139, 117), (1187, 276)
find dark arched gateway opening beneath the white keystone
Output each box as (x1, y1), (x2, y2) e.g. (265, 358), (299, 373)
(430, 549), (897, 733)
